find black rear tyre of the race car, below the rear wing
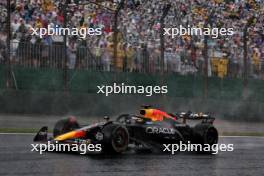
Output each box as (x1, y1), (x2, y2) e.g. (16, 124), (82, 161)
(193, 124), (218, 151)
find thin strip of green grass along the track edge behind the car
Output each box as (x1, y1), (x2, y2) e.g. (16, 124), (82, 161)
(0, 128), (264, 136)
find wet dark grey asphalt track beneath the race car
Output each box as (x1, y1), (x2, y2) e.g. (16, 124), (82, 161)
(0, 134), (264, 176)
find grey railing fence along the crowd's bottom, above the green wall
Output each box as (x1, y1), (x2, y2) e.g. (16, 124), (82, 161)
(0, 41), (264, 79)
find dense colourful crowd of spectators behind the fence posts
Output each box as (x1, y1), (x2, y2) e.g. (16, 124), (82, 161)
(0, 0), (264, 79)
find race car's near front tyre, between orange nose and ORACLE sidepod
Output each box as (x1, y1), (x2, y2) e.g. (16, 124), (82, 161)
(102, 124), (129, 154)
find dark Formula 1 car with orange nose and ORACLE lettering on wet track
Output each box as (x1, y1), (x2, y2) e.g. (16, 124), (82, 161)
(34, 106), (218, 153)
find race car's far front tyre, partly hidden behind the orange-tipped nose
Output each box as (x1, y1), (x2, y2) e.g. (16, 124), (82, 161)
(53, 118), (80, 138)
